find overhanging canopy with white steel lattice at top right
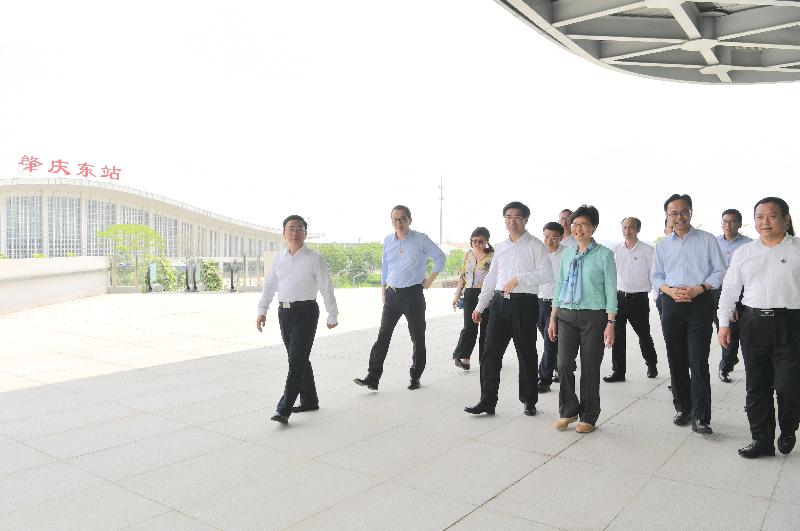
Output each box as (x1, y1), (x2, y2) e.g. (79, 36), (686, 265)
(496, 0), (800, 84)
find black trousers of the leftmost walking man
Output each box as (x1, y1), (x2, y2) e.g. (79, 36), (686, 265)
(277, 301), (319, 417)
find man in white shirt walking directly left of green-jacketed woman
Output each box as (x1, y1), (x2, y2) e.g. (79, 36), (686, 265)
(464, 201), (555, 416)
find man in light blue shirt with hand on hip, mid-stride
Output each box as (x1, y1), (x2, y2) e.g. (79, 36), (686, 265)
(353, 205), (445, 390)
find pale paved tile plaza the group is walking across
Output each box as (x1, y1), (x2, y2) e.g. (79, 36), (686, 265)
(0, 290), (800, 531)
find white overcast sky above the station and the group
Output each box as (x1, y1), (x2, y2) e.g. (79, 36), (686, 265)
(0, 0), (800, 245)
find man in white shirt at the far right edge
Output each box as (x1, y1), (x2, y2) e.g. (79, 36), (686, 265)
(717, 197), (800, 458)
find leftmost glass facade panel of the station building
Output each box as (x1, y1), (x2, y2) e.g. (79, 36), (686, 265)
(6, 195), (44, 258)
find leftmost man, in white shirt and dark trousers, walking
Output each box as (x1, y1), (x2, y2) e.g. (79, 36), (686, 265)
(256, 215), (339, 424)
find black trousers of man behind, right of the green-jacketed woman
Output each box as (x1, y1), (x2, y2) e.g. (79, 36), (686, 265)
(611, 292), (658, 374)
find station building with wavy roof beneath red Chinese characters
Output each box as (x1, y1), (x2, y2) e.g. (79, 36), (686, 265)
(0, 178), (284, 262)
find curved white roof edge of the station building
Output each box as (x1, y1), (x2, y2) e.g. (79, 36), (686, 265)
(0, 177), (281, 234)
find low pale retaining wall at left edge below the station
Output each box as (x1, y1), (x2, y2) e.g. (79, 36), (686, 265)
(0, 256), (108, 315)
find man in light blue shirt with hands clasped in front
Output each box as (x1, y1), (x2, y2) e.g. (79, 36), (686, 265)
(650, 194), (726, 434)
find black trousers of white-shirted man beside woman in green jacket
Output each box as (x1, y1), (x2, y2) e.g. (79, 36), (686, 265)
(481, 293), (539, 406)
